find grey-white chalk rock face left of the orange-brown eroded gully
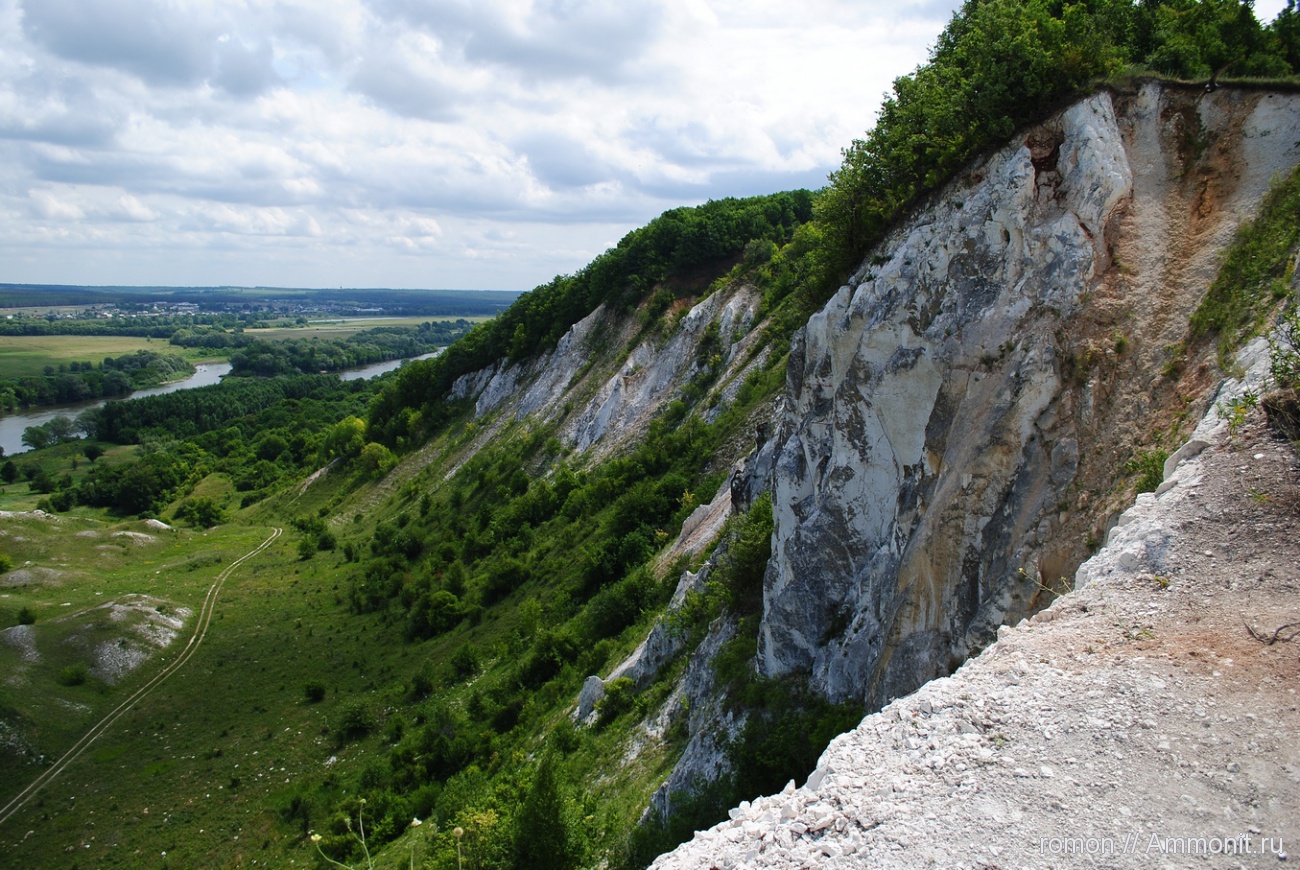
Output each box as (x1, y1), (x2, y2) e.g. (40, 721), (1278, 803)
(761, 94), (1132, 700)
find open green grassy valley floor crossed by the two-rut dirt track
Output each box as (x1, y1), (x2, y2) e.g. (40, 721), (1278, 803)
(0, 504), (421, 867)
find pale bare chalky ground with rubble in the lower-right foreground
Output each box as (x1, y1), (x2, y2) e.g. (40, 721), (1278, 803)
(655, 348), (1300, 869)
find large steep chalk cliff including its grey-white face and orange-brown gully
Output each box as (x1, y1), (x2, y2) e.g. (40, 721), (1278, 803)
(639, 82), (1300, 842)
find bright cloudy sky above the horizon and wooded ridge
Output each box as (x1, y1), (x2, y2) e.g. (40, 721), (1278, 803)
(0, 0), (1283, 290)
